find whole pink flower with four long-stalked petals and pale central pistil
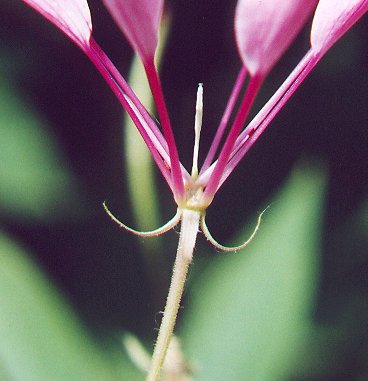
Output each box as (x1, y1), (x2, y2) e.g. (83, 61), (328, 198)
(23, 0), (368, 240)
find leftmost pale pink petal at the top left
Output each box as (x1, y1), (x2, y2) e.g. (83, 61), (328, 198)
(23, 0), (92, 50)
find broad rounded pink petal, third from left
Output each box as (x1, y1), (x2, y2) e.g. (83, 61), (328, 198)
(235, 0), (317, 75)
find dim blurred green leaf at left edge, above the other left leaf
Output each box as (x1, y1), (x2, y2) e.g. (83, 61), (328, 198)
(0, 73), (80, 219)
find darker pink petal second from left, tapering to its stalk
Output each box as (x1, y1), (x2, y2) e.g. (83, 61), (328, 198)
(104, 0), (164, 62)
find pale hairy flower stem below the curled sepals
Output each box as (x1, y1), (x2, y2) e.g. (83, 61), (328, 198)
(146, 209), (201, 381)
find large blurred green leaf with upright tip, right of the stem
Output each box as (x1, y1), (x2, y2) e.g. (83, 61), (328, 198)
(182, 163), (324, 381)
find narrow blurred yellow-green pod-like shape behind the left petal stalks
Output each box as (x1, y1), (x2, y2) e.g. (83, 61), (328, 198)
(123, 16), (170, 304)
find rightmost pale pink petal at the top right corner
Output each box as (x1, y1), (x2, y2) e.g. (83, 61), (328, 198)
(311, 0), (368, 54)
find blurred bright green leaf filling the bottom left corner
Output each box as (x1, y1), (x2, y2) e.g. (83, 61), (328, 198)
(0, 233), (142, 381)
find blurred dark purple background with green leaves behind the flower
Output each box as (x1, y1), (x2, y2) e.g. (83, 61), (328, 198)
(0, 0), (368, 381)
